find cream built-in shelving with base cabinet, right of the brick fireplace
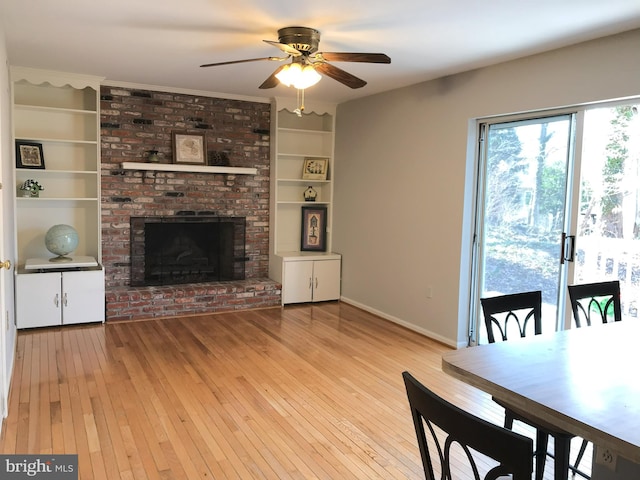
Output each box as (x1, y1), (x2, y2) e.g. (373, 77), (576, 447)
(269, 99), (341, 304)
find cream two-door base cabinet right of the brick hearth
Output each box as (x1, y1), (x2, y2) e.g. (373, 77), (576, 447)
(271, 253), (341, 305)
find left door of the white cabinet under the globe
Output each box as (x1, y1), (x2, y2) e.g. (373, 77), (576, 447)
(16, 272), (62, 328)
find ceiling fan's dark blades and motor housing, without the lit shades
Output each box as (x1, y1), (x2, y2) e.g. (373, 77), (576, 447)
(200, 27), (391, 89)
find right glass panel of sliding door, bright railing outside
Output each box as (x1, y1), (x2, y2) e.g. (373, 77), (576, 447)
(570, 103), (640, 319)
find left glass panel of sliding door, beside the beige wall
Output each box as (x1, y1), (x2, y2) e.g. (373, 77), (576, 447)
(473, 114), (575, 343)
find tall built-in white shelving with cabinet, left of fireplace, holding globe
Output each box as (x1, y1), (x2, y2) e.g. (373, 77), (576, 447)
(11, 67), (104, 328)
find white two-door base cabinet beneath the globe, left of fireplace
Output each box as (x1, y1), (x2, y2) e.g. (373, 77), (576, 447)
(16, 267), (105, 328)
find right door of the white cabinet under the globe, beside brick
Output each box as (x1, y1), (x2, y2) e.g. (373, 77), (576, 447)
(62, 270), (104, 325)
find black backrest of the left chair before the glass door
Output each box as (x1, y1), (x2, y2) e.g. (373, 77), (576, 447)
(480, 290), (542, 343)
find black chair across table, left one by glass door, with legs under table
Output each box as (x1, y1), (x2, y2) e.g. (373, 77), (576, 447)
(480, 290), (588, 480)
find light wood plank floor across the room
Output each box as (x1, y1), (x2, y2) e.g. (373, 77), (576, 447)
(0, 303), (592, 480)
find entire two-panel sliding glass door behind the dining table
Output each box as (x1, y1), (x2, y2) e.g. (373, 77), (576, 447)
(469, 101), (640, 344)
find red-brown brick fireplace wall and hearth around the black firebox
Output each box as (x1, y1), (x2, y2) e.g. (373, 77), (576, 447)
(100, 86), (280, 320)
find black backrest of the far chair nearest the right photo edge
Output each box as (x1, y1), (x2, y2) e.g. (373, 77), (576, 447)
(568, 280), (622, 328)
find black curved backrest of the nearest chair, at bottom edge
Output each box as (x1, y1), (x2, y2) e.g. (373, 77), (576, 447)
(402, 372), (533, 480)
